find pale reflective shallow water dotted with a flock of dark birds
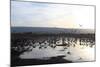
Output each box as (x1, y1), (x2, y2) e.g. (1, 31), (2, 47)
(15, 37), (95, 62)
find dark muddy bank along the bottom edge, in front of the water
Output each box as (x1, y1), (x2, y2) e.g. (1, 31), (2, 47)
(11, 56), (72, 67)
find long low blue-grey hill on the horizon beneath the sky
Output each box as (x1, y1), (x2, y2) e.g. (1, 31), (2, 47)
(11, 27), (95, 34)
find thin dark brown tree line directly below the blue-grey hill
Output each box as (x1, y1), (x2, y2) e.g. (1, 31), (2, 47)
(11, 32), (95, 39)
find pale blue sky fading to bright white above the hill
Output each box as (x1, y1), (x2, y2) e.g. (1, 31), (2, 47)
(11, 1), (94, 29)
